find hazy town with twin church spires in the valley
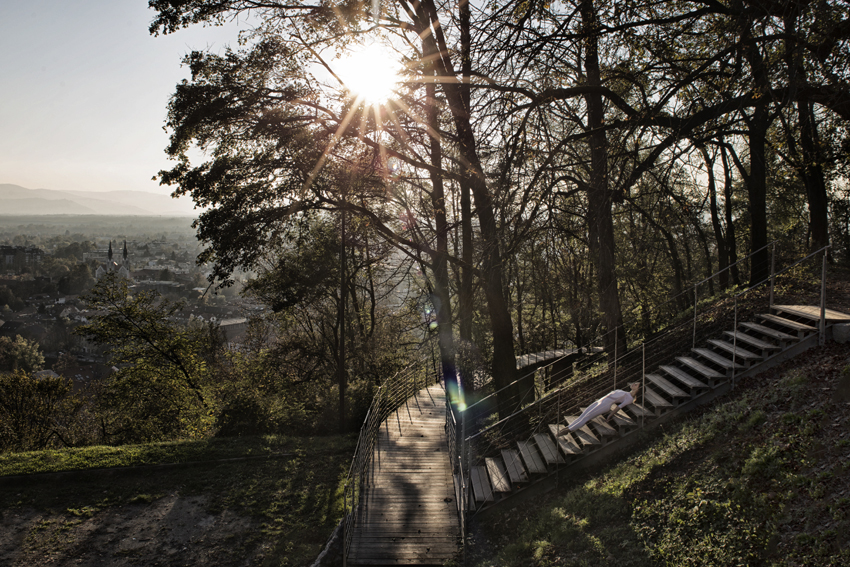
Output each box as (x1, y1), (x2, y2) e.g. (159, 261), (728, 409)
(0, 215), (250, 382)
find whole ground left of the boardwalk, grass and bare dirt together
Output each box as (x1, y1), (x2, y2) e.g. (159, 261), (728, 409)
(0, 436), (356, 567)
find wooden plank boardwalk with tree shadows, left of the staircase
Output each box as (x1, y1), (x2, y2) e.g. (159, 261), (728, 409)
(348, 385), (460, 565)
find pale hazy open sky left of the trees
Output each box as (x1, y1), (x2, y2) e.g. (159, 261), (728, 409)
(0, 0), (245, 193)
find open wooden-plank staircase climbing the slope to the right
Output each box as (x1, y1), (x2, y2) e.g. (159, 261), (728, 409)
(463, 305), (850, 518)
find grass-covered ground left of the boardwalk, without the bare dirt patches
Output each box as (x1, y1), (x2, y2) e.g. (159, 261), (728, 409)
(0, 436), (356, 565)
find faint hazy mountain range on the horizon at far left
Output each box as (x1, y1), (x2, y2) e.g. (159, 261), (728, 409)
(0, 183), (198, 217)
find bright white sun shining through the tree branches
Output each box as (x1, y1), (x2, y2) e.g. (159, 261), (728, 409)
(334, 43), (401, 104)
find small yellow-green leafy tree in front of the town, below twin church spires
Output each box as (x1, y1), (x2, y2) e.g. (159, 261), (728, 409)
(76, 274), (219, 443)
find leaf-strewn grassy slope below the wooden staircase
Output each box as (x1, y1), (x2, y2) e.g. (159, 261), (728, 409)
(469, 343), (850, 567)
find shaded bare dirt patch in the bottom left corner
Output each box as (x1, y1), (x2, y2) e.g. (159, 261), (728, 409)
(0, 492), (261, 567)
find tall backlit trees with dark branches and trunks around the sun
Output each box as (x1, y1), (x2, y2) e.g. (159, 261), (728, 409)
(149, 0), (850, 418)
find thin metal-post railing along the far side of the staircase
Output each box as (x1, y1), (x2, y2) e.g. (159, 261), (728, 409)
(453, 243), (828, 534)
